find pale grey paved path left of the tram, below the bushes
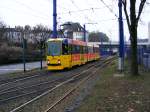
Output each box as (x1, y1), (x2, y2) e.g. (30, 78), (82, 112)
(0, 61), (46, 74)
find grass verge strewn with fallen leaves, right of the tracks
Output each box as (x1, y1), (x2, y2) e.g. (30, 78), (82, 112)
(76, 61), (150, 112)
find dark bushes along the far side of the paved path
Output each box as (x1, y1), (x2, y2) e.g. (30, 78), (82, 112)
(0, 43), (45, 64)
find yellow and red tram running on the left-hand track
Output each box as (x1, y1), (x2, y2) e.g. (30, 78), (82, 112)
(46, 38), (100, 70)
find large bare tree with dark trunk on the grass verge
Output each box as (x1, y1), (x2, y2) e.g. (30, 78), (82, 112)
(122, 0), (146, 75)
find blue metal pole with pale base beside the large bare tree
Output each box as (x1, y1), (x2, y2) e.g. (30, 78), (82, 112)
(118, 0), (124, 71)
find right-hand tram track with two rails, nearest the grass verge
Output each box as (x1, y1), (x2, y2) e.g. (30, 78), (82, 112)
(7, 58), (115, 112)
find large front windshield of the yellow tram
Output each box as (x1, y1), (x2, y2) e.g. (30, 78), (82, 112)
(47, 42), (61, 56)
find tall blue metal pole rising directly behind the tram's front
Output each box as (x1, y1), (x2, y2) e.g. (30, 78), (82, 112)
(53, 0), (57, 38)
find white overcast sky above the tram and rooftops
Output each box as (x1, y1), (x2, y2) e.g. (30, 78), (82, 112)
(0, 0), (150, 40)
